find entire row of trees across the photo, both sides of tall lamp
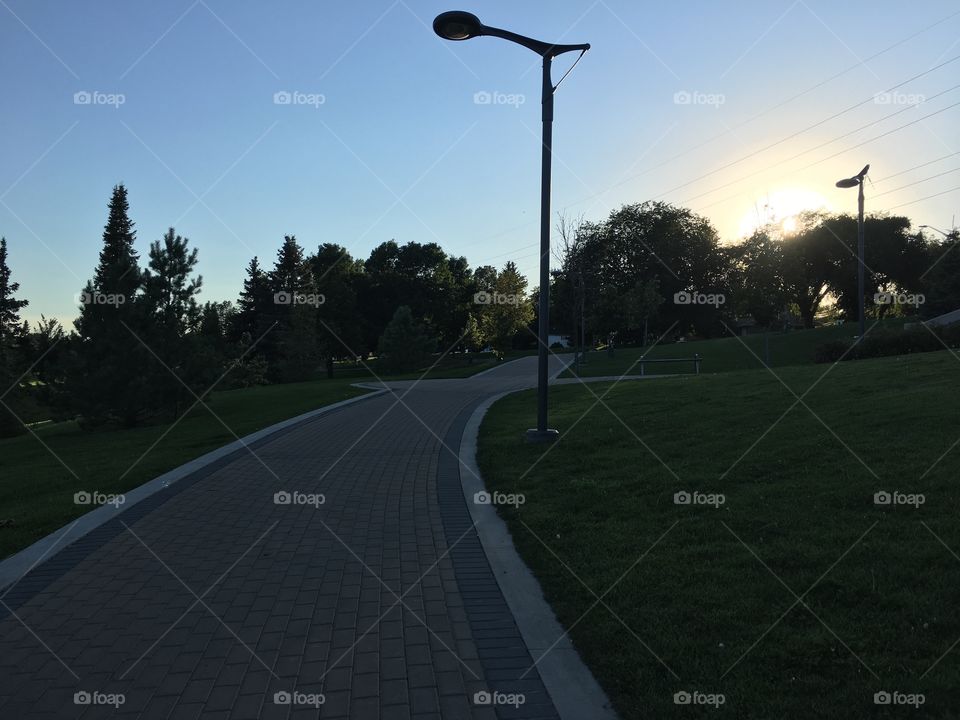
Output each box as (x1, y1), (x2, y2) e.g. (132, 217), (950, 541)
(0, 185), (960, 434)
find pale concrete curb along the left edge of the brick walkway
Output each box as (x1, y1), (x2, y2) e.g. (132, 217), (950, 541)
(0, 385), (387, 597)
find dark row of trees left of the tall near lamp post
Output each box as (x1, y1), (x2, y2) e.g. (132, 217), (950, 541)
(0, 185), (534, 435)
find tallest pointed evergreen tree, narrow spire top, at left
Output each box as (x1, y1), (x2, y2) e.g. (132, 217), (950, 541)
(68, 185), (147, 425)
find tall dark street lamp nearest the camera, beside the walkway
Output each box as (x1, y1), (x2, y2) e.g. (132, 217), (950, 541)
(433, 10), (590, 442)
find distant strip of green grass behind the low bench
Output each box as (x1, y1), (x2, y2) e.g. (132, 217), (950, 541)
(561, 319), (903, 377)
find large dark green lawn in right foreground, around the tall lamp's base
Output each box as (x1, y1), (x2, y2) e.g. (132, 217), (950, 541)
(479, 352), (960, 718)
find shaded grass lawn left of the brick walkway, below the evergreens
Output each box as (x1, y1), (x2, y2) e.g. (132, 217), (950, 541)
(0, 379), (368, 557)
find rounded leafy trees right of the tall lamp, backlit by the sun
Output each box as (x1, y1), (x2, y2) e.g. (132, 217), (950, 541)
(551, 202), (960, 346)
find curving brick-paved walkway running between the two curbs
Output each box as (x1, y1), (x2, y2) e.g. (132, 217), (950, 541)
(0, 358), (580, 720)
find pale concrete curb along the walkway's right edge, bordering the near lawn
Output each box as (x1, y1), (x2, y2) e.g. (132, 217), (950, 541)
(460, 391), (618, 720)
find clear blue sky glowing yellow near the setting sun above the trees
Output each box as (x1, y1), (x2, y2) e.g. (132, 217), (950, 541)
(0, 0), (960, 321)
